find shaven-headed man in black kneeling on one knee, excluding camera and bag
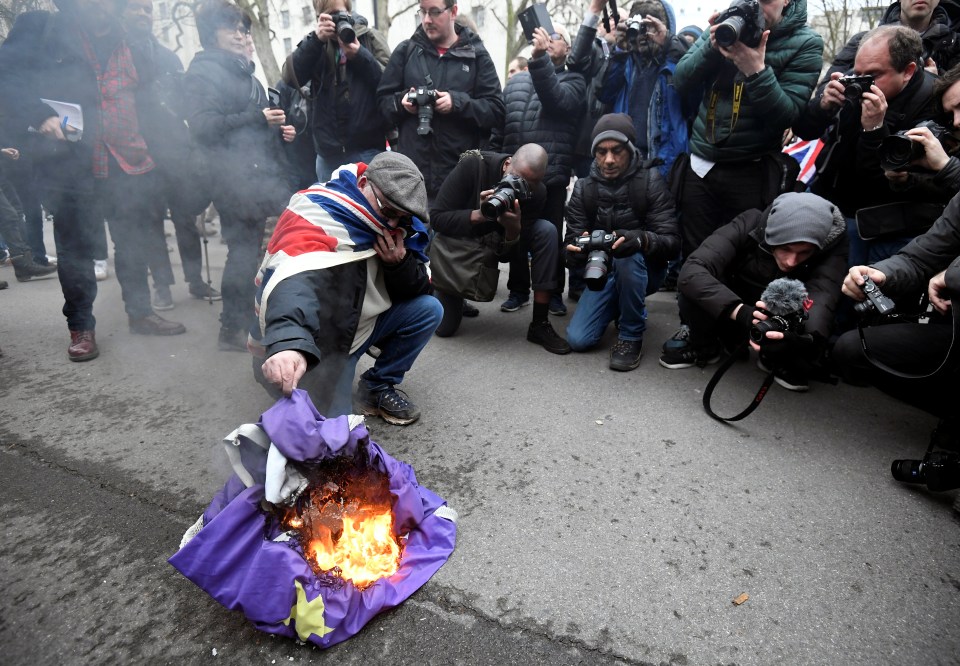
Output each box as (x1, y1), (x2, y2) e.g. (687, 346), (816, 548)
(430, 143), (570, 354)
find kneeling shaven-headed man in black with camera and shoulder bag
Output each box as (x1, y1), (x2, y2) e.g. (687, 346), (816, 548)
(430, 143), (570, 354)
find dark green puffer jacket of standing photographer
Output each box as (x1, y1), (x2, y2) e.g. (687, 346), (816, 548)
(673, 0), (823, 162)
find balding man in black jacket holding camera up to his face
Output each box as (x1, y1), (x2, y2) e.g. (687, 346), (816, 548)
(794, 26), (948, 265)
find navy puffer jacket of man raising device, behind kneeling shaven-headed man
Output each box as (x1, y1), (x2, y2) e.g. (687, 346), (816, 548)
(490, 54), (587, 186)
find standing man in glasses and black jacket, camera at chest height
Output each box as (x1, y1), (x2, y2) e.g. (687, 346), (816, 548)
(377, 0), (504, 200)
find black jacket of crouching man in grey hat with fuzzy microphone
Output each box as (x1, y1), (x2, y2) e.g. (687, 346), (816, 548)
(677, 205), (847, 341)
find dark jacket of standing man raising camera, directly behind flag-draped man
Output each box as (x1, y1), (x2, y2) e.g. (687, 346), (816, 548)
(283, 22), (390, 158)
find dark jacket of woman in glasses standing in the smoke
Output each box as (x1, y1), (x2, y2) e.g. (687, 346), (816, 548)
(184, 49), (292, 218)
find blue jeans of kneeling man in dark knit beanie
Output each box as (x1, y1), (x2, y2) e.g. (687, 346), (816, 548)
(567, 252), (667, 351)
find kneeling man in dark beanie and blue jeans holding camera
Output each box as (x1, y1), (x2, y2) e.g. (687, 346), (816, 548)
(566, 113), (680, 372)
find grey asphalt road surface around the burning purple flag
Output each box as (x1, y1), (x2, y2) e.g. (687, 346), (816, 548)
(0, 224), (960, 666)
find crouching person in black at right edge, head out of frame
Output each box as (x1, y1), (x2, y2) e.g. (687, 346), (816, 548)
(833, 189), (960, 462)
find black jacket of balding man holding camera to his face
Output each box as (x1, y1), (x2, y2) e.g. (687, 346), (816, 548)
(793, 68), (936, 217)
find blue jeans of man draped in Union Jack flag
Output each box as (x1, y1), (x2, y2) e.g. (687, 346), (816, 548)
(318, 296), (443, 417)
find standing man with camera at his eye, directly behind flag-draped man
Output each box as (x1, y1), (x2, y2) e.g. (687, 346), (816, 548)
(283, 0), (390, 182)
